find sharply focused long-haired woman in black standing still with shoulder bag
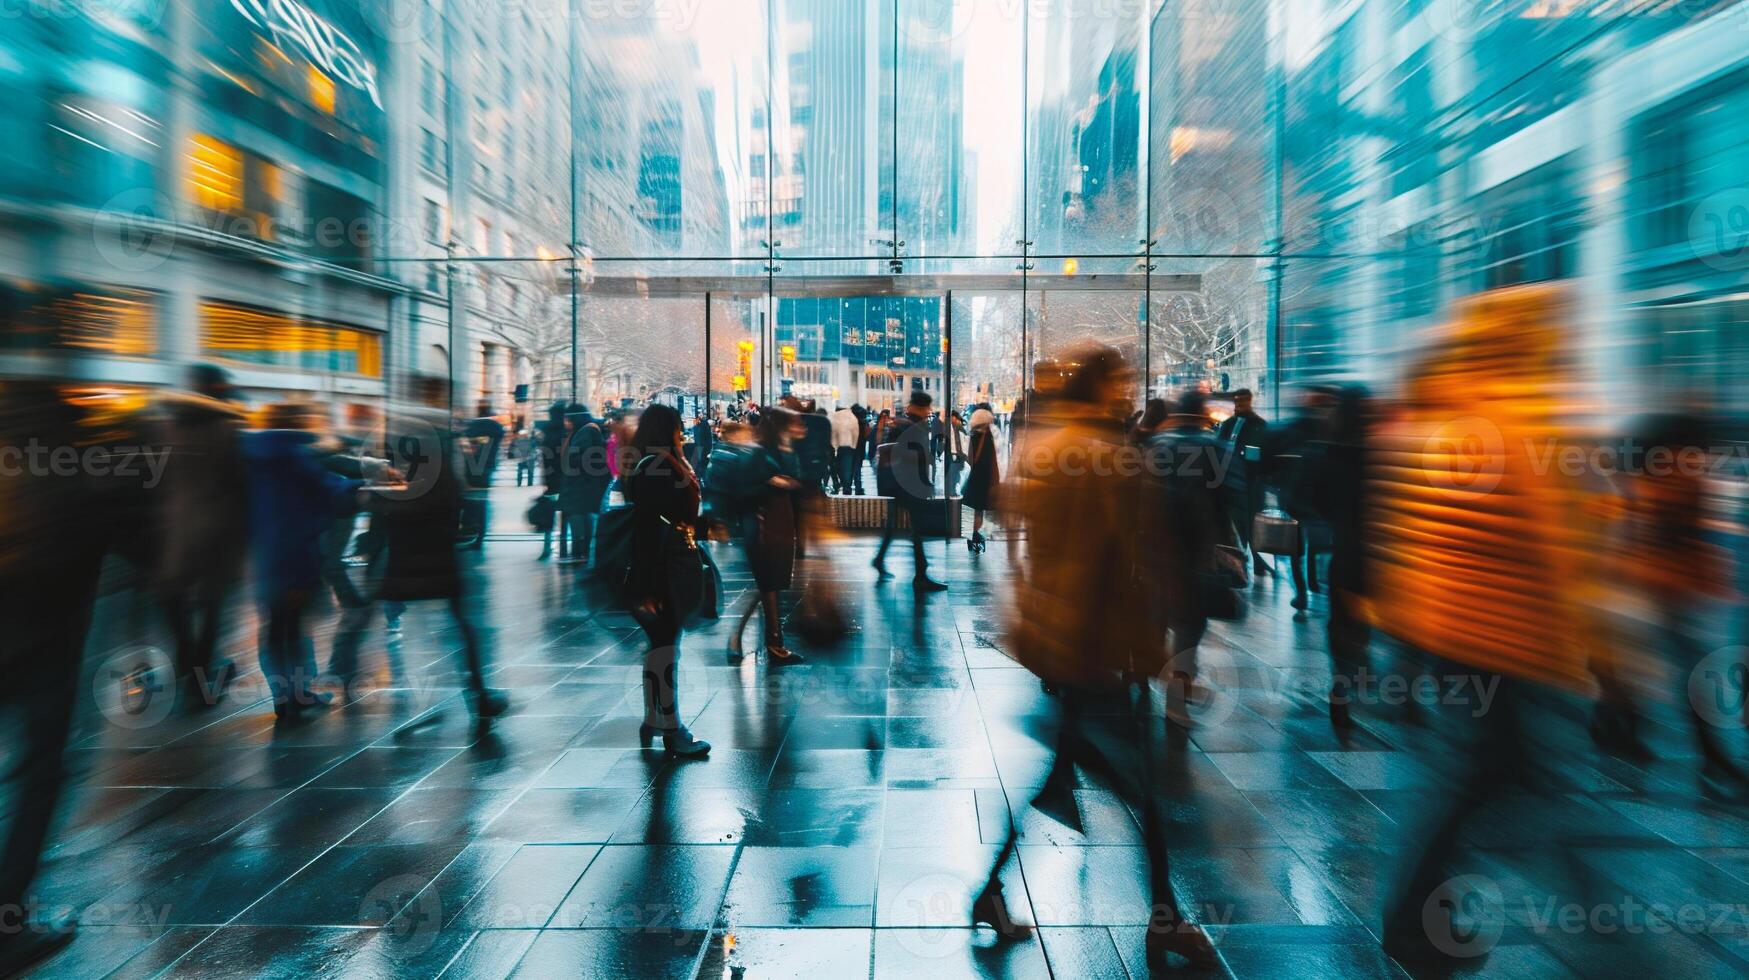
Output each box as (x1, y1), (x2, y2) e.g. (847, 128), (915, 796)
(621, 404), (710, 760)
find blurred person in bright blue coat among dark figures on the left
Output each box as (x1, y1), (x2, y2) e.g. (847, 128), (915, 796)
(243, 404), (362, 721)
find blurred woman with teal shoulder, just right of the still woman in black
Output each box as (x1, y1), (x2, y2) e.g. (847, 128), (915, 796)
(726, 408), (803, 667)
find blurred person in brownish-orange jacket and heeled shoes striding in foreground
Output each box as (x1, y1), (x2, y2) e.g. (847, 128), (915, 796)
(972, 345), (1216, 970)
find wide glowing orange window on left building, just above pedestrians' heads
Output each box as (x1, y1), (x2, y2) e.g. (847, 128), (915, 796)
(201, 303), (383, 378)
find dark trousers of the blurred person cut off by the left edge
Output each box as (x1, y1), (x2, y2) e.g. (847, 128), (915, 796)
(0, 557), (101, 924)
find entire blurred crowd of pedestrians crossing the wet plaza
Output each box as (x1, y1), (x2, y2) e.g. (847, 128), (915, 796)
(0, 285), (1749, 966)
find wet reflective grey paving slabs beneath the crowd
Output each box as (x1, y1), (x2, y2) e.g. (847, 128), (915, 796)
(20, 488), (1749, 980)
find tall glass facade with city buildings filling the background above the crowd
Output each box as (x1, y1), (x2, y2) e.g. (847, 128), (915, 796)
(0, 0), (1749, 421)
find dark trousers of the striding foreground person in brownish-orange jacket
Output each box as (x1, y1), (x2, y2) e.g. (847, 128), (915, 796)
(990, 690), (1184, 929)
